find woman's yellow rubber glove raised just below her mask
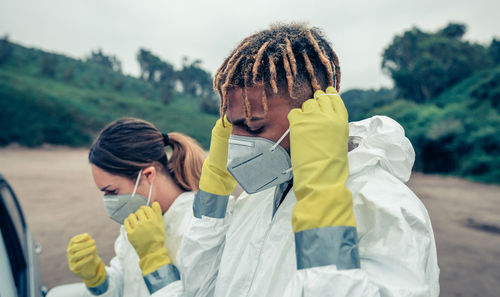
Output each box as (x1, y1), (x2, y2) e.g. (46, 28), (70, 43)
(124, 202), (171, 276)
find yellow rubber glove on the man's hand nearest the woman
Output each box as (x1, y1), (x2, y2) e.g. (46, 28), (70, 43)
(200, 119), (236, 196)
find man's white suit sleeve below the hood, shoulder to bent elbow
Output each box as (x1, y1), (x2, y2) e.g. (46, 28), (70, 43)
(284, 168), (439, 297)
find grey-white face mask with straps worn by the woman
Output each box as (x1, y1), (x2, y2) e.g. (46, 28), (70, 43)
(104, 169), (153, 225)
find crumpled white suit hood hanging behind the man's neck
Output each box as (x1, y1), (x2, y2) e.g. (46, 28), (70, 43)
(348, 116), (415, 183)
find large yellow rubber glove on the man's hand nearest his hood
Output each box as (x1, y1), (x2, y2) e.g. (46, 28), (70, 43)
(288, 87), (356, 232)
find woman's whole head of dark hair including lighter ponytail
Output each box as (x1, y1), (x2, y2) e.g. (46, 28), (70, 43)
(89, 118), (205, 191)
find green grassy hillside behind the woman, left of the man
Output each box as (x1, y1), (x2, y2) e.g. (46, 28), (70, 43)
(0, 42), (216, 148)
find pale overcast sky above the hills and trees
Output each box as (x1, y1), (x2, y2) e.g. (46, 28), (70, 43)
(0, 0), (500, 90)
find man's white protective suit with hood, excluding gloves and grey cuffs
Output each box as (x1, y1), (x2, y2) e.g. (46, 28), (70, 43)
(153, 116), (439, 297)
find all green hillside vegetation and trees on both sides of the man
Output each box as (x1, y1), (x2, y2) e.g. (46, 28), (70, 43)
(0, 23), (500, 183)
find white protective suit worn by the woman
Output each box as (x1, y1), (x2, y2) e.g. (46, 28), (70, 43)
(83, 192), (194, 297)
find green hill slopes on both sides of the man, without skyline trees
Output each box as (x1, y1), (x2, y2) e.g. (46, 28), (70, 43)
(0, 39), (500, 183)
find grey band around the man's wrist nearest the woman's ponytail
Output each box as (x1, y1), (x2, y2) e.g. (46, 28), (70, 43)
(193, 190), (229, 219)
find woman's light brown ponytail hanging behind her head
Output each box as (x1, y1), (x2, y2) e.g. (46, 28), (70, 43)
(168, 132), (205, 191)
